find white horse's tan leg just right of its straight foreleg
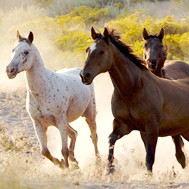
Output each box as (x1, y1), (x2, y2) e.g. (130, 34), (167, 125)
(68, 124), (78, 165)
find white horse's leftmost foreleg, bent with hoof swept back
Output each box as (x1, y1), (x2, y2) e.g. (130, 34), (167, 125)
(33, 121), (63, 167)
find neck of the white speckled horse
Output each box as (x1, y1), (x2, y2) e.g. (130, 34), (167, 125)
(25, 46), (48, 93)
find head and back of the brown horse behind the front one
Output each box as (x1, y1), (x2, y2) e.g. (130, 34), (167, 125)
(142, 28), (189, 79)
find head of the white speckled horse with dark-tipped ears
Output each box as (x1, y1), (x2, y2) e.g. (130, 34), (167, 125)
(6, 31), (34, 79)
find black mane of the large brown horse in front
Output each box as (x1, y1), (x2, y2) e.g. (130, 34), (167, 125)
(98, 30), (148, 70)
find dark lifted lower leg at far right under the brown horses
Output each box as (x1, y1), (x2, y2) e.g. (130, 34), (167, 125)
(172, 135), (186, 168)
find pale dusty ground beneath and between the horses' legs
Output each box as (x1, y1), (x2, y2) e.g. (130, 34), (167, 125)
(0, 75), (189, 189)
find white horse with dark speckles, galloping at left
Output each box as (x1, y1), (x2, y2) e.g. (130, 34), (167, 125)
(6, 31), (100, 169)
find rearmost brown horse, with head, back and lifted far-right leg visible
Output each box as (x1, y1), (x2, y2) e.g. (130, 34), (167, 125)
(141, 28), (185, 168)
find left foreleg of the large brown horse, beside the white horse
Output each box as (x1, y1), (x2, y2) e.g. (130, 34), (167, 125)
(107, 119), (132, 174)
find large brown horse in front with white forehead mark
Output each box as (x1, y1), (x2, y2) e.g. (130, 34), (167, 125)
(80, 28), (189, 172)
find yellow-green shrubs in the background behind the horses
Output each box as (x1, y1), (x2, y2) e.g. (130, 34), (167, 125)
(0, 0), (189, 69)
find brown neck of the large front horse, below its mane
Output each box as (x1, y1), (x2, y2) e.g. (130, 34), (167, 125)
(109, 45), (141, 96)
